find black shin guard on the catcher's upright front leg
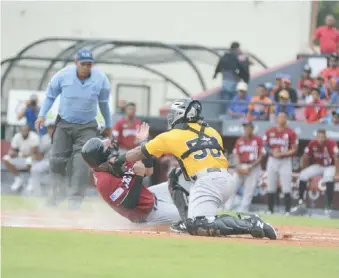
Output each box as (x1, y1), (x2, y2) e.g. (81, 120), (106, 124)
(168, 169), (189, 221)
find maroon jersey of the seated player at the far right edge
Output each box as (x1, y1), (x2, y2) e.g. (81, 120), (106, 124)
(305, 139), (339, 166)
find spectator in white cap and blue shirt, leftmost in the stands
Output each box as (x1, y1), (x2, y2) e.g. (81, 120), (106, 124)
(227, 82), (251, 119)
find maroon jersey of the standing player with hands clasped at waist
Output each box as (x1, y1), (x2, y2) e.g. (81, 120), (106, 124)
(264, 127), (298, 153)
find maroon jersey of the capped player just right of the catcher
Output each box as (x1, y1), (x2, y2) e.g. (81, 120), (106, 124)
(233, 136), (264, 163)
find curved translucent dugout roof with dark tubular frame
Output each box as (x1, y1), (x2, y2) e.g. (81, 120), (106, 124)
(1, 37), (267, 96)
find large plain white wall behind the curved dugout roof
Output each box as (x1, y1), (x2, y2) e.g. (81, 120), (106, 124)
(1, 1), (311, 114)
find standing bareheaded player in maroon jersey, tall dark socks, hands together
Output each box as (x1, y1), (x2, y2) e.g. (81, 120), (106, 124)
(264, 112), (298, 215)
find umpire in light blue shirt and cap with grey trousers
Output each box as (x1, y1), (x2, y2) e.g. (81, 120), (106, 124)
(35, 49), (112, 209)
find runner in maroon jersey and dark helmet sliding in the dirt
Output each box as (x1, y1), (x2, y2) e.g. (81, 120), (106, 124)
(81, 138), (189, 225)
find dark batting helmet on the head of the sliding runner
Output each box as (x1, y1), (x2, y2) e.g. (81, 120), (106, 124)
(81, 138), (119, 168)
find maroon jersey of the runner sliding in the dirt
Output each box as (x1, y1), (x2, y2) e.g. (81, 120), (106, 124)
(94, 163), (155, 222)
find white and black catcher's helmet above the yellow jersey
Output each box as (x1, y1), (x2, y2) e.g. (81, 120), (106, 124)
(167, 98), (202, 129)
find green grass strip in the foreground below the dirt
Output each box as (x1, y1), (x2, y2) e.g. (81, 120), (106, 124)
(2, 228), (339, 278)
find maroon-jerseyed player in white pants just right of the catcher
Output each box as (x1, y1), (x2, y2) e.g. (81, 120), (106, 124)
(233, 121), (265, 212)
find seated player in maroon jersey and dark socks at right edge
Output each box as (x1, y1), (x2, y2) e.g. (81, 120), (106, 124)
(292, 129), (339, 215)
